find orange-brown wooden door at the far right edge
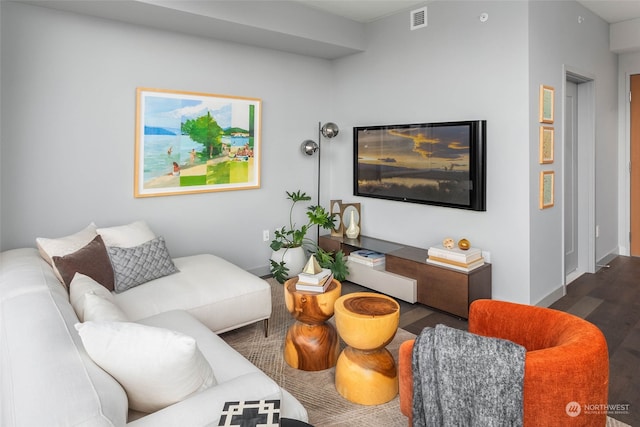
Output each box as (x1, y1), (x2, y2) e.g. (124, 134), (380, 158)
(629, 74), (640, 256)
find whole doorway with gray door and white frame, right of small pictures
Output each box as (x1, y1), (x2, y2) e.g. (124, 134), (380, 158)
(562, 70), (595, 285)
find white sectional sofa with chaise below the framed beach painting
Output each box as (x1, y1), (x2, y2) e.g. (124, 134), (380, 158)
(0, 222), (307, 426)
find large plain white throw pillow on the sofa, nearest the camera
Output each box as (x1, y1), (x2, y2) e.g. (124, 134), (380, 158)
(75, 322), (216, 413)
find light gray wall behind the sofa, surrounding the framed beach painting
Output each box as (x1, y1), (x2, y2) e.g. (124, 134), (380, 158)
(1, 2), (333, 272)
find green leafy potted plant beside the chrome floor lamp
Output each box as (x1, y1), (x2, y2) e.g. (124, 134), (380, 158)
(270, 190), (348, 283)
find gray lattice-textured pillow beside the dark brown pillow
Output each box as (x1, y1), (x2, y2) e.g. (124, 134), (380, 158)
(107, 237), (178, 293)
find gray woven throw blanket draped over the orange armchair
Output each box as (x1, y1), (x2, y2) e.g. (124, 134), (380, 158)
(412, 325), (526, 427)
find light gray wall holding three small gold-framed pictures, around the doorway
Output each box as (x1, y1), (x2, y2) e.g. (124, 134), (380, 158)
(529, 1), (618, 303)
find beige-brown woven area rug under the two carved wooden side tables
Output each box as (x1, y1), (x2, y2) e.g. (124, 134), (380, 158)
(220, 279), (415, 427)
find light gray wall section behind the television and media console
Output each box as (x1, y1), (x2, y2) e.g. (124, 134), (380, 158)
(325, 2), (529, 302)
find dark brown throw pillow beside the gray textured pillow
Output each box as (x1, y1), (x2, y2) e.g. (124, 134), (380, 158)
(53, 235), (114, 291)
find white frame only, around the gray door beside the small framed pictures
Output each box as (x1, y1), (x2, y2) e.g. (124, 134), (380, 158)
(556, 65), (596, 293)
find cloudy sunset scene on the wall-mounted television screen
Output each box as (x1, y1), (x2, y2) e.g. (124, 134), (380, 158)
(357, 125), (470, 205)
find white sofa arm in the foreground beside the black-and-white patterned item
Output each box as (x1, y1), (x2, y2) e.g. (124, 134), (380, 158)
(127, 372), (282, 427)
